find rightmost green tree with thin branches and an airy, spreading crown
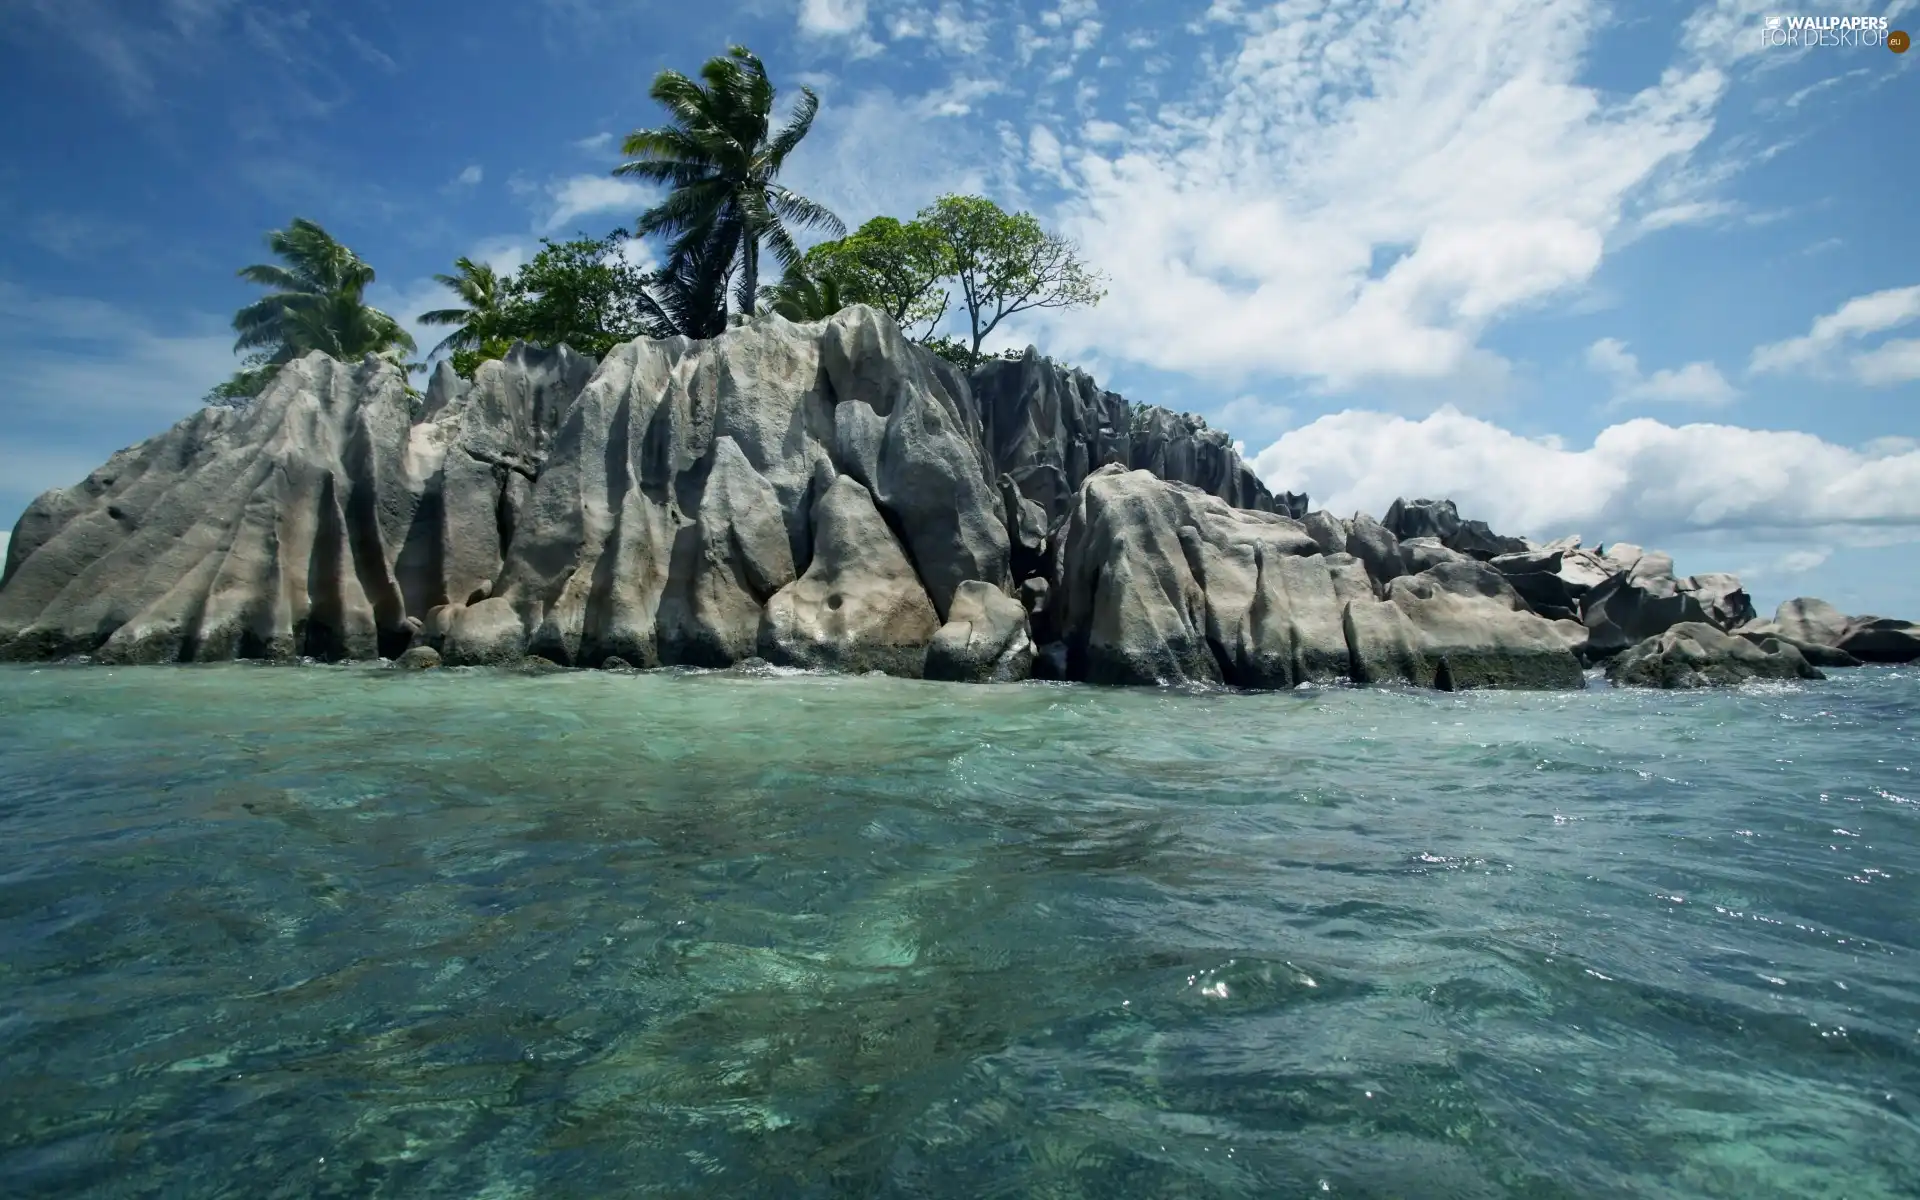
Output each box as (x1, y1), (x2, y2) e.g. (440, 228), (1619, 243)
(914, 196), (1106, 365)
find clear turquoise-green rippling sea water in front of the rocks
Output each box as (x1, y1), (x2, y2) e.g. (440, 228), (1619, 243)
(0, 666), (1920, 1200)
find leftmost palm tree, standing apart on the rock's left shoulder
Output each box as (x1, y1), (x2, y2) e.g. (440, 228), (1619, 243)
(207, 217), (415, 405)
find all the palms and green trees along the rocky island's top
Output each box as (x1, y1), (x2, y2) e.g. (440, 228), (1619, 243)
(209, 46), (1102, 403)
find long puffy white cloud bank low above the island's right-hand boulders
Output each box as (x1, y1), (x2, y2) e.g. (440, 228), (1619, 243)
(1254, 407), (1920, 543)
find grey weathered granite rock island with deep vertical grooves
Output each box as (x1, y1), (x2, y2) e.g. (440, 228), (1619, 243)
(0, 305), (1920, 689)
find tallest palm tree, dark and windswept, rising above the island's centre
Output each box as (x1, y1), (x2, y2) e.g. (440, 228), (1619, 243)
(614, 46), (847, 322)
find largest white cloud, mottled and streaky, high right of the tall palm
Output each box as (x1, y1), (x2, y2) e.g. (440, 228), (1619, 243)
(1043, 0), (1726, 388)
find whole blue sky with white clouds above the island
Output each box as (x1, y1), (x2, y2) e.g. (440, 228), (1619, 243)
(0, 0), (1920, 618)
